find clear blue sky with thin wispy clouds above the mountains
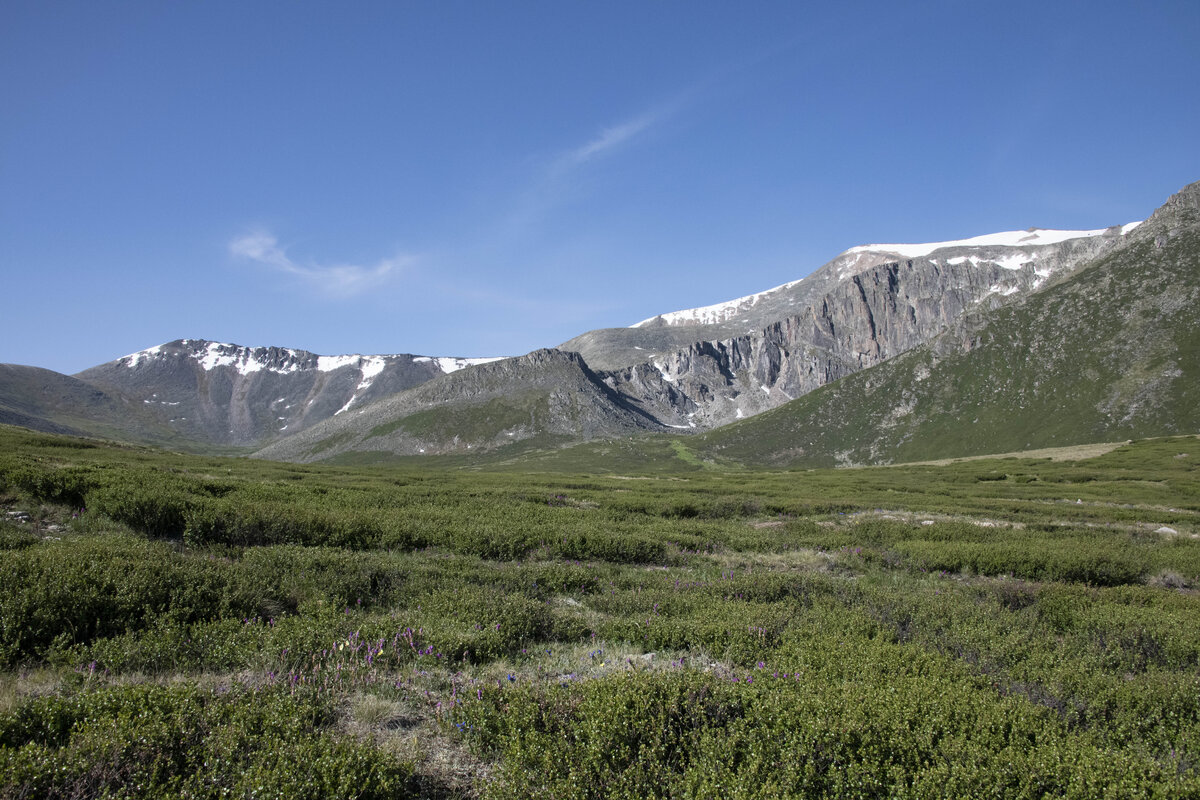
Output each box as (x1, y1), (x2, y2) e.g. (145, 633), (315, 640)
(0, 0), (1200, 373)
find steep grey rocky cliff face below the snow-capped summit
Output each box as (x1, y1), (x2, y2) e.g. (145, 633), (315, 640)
(604, 228), (1123, 429)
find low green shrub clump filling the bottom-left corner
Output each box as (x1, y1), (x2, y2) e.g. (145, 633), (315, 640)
(0, 685), (412, 800)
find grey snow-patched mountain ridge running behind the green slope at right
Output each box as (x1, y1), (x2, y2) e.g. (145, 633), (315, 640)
(0, 184), (1180, 461)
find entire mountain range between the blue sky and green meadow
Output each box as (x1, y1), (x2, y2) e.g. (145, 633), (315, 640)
(0, 184), (1200, 465)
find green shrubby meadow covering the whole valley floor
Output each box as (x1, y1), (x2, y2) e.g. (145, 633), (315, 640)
(0, 428), (1200, 798)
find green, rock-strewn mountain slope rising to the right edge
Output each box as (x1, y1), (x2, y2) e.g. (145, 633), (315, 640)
(689, 182), (1200, 467)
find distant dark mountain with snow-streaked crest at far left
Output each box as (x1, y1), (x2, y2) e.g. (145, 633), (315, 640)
(0, 339), (496, 451)
